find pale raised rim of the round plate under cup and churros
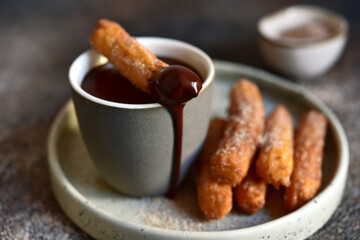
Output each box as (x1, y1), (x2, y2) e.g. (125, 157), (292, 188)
(47, 59), (349, 239)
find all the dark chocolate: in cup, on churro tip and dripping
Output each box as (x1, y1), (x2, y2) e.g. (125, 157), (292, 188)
(81, 58), (202, 198)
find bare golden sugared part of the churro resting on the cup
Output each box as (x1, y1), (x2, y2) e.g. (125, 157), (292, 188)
(90, 19), (168, 93)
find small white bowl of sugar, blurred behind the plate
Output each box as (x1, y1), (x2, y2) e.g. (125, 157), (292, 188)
(257, 5), (348, 78)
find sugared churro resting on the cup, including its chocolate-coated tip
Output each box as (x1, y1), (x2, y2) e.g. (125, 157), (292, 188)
(90, 19), (202, 106)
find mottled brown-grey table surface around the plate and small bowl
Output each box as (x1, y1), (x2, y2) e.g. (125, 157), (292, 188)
(0, 0), (360, 239)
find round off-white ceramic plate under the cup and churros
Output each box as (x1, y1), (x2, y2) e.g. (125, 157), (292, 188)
(48, 61), (349, 240)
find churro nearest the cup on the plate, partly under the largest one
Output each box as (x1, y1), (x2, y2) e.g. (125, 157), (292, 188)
(196, 118), (233, 219)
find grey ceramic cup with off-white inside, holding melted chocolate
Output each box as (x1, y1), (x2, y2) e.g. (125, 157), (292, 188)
(69, 37), (215, 196)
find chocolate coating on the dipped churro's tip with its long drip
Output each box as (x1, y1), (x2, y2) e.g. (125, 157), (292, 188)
(149, 65), (202, 198)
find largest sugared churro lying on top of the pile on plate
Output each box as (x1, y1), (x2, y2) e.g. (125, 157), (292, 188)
(210, 80), (264, 186)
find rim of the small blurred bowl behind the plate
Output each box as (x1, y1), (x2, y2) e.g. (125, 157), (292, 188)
(256, 4), (349, 48)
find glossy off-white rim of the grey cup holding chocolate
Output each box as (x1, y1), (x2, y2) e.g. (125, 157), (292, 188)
(68, 37), (215, 109)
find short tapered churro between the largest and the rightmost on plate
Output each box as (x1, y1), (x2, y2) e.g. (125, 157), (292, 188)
(256, 105), (293, 189)
